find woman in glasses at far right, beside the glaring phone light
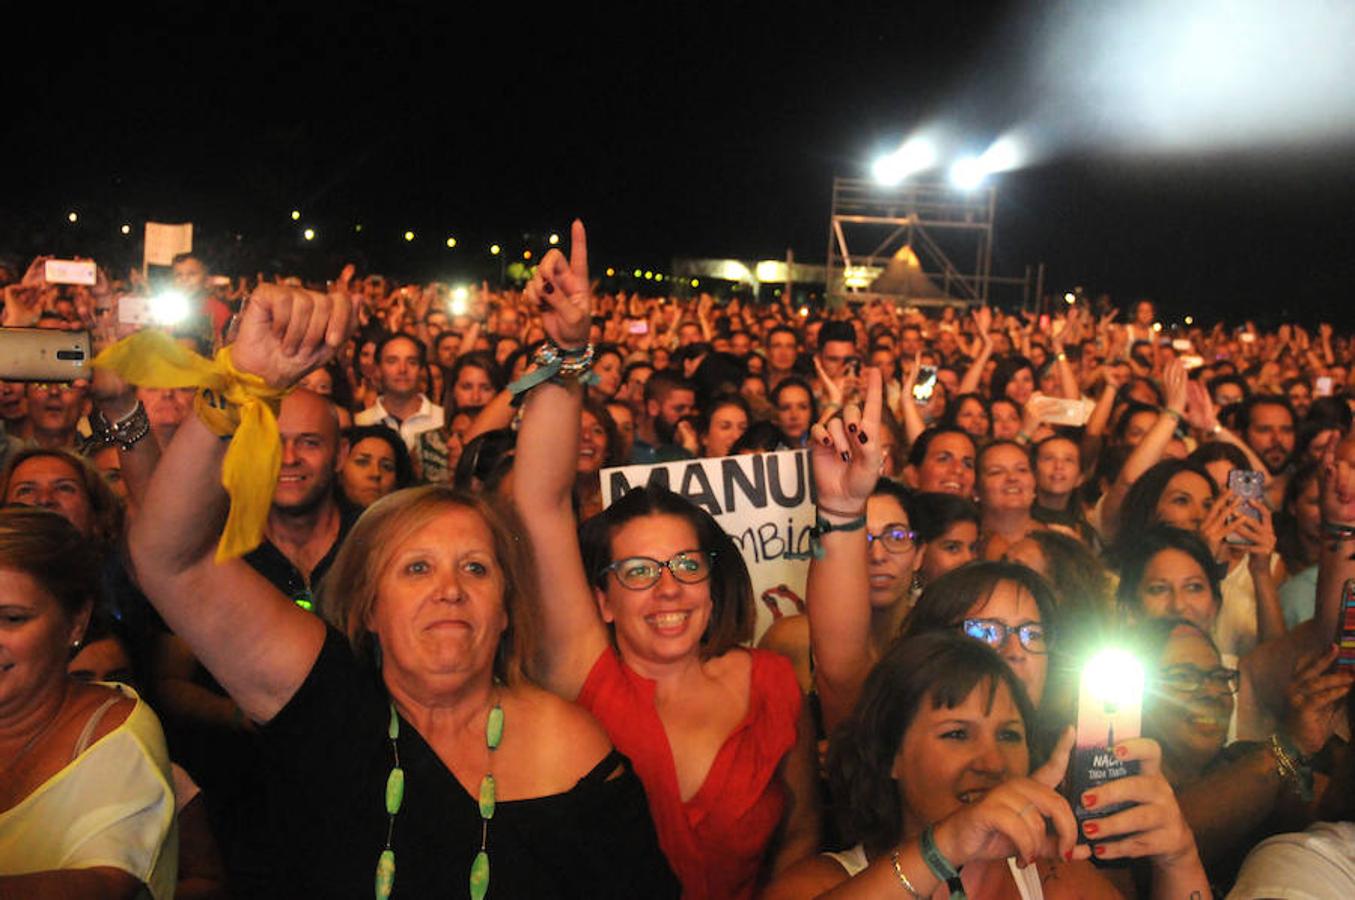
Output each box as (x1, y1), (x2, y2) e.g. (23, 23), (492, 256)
(1127, 617), (1355, 896)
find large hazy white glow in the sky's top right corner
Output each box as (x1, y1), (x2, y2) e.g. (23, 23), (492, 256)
(1026, 0), (1355, 156)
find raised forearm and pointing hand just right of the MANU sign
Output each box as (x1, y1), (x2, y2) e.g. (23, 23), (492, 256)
(805, 369), (882, 732)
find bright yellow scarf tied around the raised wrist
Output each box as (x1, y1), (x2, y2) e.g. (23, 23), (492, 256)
(92, 331), (287, 563)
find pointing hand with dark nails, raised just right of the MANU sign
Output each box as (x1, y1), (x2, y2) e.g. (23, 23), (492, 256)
(809, 367), (883, 516)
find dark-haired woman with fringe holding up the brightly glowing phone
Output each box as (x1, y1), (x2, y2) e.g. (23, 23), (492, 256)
(763, 632), (1207, 900)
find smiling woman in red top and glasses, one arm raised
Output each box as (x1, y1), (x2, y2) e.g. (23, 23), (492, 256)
(514, 225), (818, 899)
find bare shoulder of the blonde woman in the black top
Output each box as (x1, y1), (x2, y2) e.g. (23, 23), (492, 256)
(504, 684), (611, 792)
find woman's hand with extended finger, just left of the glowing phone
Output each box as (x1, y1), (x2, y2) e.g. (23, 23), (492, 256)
(935, 728), (1078, 866)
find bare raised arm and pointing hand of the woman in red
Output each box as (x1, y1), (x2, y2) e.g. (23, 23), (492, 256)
(512, 221), (607, 701)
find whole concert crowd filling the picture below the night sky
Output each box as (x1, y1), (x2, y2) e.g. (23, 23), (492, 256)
(0, 222), (1355, 900)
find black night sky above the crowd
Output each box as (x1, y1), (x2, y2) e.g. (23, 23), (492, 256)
(10, 1), (1355, 324)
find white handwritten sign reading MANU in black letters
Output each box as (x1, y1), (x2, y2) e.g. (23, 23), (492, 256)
(600, 450), (814, 641)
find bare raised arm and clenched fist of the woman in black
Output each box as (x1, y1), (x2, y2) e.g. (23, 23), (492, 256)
(129, 277), (354, 721)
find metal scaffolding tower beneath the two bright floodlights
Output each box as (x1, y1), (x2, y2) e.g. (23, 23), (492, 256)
(828, 178), (1030, 306)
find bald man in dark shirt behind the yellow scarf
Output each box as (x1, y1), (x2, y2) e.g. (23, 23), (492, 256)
(245, 390), (360, 610)
